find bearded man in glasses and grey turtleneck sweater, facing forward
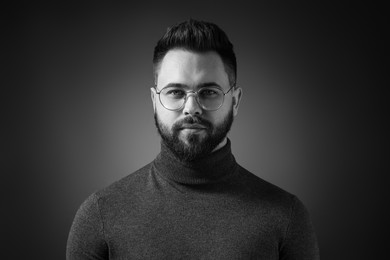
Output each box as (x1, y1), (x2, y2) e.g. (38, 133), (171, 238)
(67, 20), (319, 260)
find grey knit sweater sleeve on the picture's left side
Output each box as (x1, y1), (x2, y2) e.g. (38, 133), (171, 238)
(66, 194), (108, 260)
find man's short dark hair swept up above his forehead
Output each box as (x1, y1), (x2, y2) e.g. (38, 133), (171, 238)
(153, 19), (237, 86)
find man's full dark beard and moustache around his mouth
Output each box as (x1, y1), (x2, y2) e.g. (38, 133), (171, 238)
(154, 109), (234, 162)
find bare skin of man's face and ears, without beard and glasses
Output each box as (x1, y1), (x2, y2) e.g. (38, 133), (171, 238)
(151, 49), (242, 150)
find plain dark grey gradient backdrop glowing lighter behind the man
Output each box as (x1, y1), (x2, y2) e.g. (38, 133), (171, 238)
(7, 0), (388, 259)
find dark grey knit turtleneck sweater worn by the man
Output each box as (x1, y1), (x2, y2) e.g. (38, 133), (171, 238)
(66, 140), (319, 260)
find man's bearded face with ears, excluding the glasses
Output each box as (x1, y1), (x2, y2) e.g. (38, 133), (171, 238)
(151, 49), (241, 161)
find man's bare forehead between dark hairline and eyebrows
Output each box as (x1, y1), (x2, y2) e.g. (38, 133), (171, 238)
(157, 49), (229, 87)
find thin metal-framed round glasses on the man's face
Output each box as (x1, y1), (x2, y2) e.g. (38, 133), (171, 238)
(156, 86), (234, 111)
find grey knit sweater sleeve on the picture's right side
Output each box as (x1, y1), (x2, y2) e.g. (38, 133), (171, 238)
(280, 196), (320, 260)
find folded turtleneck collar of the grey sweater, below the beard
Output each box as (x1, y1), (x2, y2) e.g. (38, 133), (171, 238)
(153, 139), (238, 184)
